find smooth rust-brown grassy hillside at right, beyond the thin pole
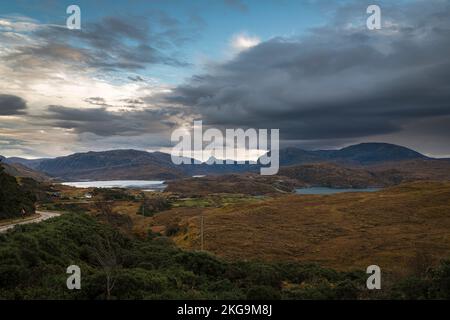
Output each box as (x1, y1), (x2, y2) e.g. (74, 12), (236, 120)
(152, 182), (450, 274)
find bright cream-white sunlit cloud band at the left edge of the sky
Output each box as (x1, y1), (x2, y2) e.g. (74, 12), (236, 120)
(0, 17), (170, 114)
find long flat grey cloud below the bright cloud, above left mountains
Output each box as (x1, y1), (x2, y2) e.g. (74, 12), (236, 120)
(42, 106), (179, 137)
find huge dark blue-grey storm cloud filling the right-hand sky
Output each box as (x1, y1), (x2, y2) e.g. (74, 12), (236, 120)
(166, 1), (450, 144)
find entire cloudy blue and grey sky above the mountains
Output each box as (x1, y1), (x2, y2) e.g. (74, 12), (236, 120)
(0, 0), (450, 158)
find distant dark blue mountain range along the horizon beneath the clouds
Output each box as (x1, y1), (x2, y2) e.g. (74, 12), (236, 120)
(2, 143), (448, 181)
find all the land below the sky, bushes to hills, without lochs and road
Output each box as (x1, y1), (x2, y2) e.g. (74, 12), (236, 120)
(0, 144), (450, 299)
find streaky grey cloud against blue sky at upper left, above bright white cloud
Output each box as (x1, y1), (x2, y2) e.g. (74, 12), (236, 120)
(6, 13), (198, 71)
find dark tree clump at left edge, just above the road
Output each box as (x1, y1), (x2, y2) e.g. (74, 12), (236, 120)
(0, 164), (35, 219)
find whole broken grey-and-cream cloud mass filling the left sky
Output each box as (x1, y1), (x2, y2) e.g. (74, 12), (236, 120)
(0, 10), (204, 156)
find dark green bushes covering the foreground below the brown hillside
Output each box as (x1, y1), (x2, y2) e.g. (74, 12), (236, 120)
(0, 214), (450, 299)
